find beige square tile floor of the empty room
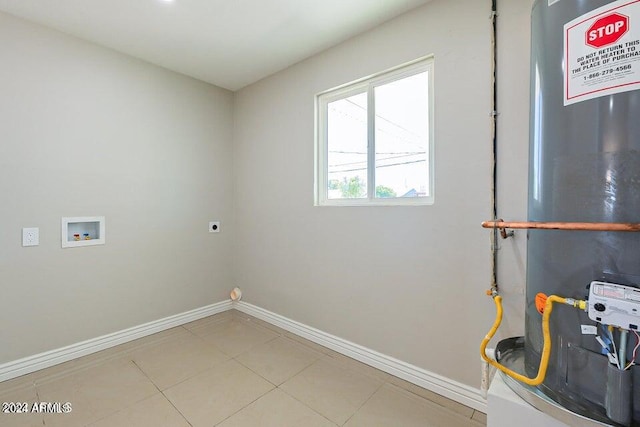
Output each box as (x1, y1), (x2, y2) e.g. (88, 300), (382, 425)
(0, 310), (486, 427)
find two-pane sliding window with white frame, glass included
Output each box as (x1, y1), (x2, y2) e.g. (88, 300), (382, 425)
(315, 58), (433, 206)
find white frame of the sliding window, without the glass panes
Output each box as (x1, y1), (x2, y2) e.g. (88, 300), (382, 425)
(314, 55), (435, 206)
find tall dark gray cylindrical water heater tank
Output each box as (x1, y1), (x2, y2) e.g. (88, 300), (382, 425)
(525, 0), (640, 425)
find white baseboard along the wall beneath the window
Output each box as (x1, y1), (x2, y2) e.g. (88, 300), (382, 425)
(233, 301), (487, 413)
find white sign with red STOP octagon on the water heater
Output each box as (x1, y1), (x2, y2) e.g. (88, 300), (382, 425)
(562, 0), (640, 105)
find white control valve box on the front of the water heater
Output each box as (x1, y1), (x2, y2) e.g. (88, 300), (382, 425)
(587, 281), (640, 330)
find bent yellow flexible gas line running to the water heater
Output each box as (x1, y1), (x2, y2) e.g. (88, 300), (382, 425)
(480, 292), (586, 386)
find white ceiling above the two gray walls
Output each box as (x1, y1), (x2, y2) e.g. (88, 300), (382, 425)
(0, 0), (430, 90)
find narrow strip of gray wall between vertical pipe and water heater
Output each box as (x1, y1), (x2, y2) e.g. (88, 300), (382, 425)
(498, 0), (534, 337)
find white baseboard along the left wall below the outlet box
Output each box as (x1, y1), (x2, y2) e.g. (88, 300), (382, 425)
(0, 301), (233, 381)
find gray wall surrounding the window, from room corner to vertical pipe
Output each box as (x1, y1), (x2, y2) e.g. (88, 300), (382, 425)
(234, 0), (528, 386)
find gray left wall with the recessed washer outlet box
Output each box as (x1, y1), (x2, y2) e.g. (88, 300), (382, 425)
(0, 14), (233, 363)
